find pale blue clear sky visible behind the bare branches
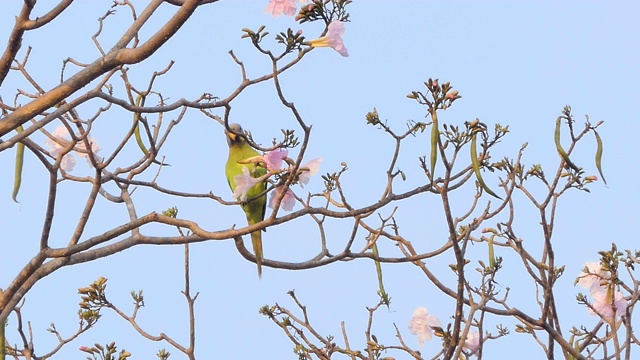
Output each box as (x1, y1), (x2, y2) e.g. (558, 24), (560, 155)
(0, 0), (640, 359)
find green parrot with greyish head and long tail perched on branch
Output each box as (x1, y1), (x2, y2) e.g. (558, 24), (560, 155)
(225, 124), (267, 277)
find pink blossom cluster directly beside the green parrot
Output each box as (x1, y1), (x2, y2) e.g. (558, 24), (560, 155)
(233, 149), (322, 211)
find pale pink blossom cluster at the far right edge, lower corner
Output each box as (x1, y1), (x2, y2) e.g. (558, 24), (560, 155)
(577, 262), (628, 321)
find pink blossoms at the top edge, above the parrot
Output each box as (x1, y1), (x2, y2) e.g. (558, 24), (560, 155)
(264, 0), (349, 57)
